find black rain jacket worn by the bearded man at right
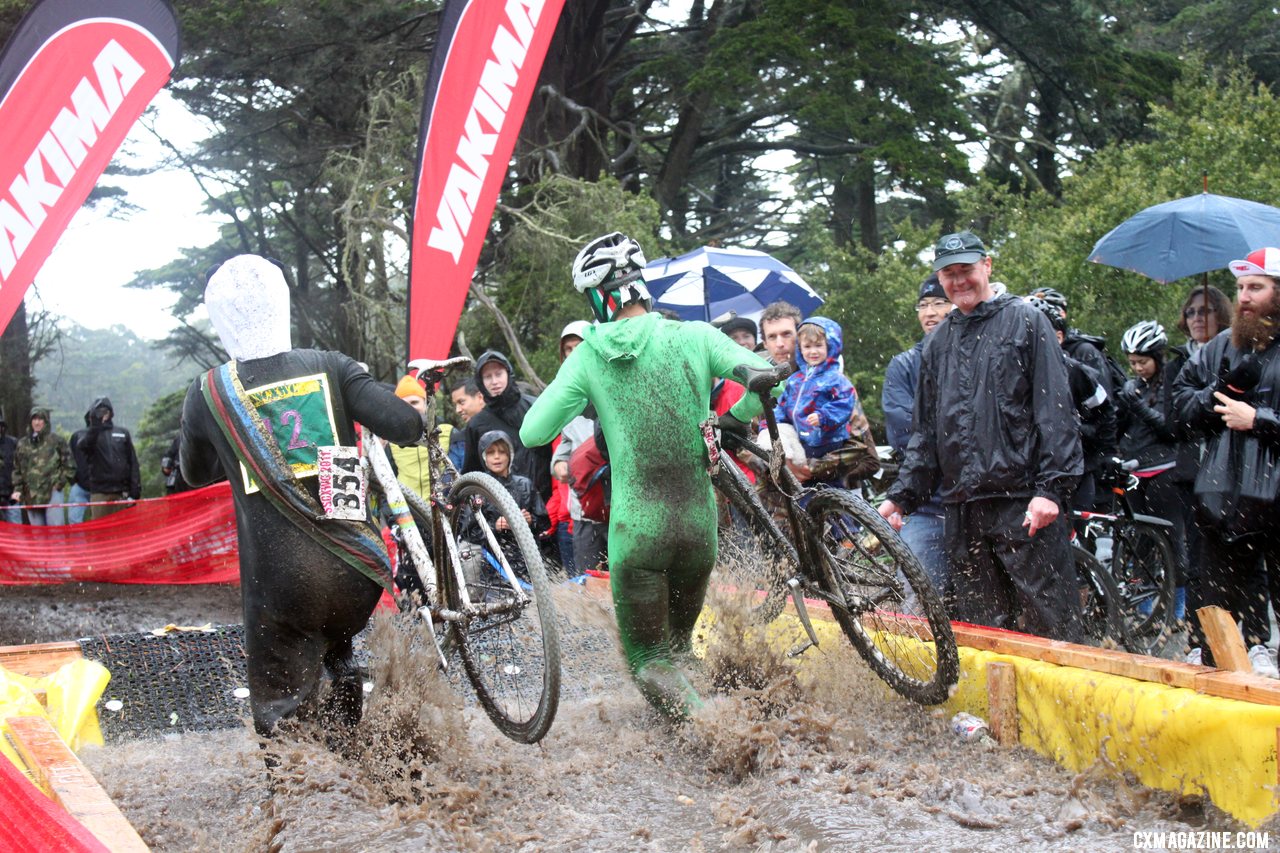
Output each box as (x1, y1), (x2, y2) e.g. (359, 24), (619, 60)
(1174, 329), (1280, 539)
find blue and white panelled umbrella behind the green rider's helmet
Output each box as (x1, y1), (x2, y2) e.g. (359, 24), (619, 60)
(644, 247), (823, 321)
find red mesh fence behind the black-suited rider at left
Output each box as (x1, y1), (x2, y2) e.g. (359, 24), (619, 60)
(0, 482), (239, 585)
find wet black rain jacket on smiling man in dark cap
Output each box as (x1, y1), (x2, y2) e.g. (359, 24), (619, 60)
(888, 293), (1084, 512)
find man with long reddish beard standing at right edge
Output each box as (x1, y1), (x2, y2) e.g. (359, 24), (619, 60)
(1174, 247), (1280, 678)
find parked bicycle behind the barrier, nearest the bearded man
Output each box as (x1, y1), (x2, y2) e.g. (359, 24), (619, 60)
(1071, 460), (1178, 654)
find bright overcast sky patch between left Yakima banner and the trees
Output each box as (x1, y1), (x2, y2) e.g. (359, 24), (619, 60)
(27, 91), (218, 339)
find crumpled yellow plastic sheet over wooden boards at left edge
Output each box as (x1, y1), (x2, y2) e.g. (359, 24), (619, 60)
(0, 658), (111, 771)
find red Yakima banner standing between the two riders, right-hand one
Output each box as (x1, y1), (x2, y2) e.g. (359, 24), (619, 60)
(408, 0), (564, 359)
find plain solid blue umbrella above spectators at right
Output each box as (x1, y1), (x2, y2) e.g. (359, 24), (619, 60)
(1089, 192), (1280, 283)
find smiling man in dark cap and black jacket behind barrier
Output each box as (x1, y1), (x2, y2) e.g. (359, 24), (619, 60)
(879, 231), (1083, 642)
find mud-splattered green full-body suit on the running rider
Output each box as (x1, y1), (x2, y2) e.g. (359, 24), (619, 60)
(520, 308), (769, 717)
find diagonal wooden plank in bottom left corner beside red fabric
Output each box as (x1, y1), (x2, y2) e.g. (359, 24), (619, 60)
(8, 717), (148, 853)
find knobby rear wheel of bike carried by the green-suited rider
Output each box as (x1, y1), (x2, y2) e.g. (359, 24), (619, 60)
(808, 489), (960, 704)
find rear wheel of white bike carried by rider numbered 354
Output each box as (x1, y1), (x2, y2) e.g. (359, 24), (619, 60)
(442, 473), (561, 743)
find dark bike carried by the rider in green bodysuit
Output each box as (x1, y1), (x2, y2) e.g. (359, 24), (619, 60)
(704, 368), (960, 704)
